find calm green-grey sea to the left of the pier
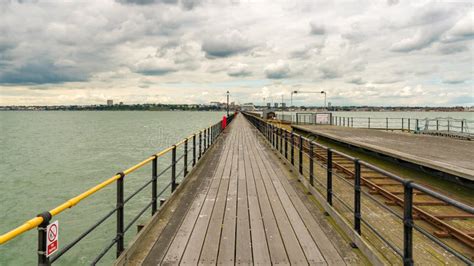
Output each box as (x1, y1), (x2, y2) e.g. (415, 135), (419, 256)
(0, 111), (224, 265)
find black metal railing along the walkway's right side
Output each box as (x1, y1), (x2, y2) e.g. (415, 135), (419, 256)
(243, 112), (474, 265)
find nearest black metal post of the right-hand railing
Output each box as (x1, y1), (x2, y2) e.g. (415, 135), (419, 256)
(403, 181), (413, 266)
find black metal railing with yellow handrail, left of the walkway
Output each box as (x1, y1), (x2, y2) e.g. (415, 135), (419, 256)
(0, 114), (234, 265)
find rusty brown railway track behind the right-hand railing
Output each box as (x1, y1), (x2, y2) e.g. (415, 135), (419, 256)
(282, 130), (474, 254)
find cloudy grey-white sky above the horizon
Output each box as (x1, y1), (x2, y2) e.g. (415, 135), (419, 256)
(0, 0), (474, 106)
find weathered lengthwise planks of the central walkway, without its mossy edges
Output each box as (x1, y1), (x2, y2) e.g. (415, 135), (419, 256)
(144, 116), (354, 265)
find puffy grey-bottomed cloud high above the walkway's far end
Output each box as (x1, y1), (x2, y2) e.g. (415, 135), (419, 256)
(202, 30), (254, 58)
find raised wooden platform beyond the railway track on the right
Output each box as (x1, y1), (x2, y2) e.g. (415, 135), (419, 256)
(292, 125), (474, 182)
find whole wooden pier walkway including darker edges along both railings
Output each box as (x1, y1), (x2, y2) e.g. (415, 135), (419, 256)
(121, 115), (362, 265)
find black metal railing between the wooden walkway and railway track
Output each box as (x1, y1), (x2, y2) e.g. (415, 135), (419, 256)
(243, 112), (474, 265)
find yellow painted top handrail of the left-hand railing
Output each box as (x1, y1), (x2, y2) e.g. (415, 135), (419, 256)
(0, 123), (215, 245)
